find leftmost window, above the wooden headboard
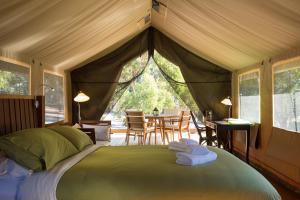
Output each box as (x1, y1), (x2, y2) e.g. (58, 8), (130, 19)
(0, 60), (30, 95)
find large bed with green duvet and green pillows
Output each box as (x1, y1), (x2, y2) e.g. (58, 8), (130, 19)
(0, 96), (281, 200)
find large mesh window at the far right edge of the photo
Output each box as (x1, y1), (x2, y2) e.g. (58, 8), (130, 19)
(273, 60), (300, 132)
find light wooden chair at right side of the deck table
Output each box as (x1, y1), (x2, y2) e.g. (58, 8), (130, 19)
(163, 111), (191, 141)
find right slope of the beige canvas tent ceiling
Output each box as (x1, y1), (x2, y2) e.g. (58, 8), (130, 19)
(152, 0), (300, 69)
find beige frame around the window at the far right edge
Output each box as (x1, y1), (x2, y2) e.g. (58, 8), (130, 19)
(271, 56), (300, 133)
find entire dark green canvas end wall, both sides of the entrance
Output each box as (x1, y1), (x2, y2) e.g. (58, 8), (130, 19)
(71, 27), (231, 122)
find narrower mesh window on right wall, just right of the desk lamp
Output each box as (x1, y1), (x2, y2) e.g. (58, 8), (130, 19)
(239, 71), (260, 123)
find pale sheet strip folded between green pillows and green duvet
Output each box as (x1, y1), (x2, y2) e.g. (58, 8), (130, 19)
(17, 142), (105, 200)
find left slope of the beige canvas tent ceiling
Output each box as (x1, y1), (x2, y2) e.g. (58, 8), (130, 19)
(0, 0), (151, 71)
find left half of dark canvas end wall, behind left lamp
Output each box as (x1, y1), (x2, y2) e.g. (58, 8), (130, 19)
(71, 30), (148, 122)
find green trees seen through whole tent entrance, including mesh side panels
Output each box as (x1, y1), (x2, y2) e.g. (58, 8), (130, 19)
(104, 52), (200, 123)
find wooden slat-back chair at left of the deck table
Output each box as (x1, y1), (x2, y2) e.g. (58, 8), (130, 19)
(125, 111), (154, 145)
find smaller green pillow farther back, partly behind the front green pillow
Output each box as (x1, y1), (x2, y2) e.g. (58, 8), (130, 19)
(50, 126), (93, 151)
